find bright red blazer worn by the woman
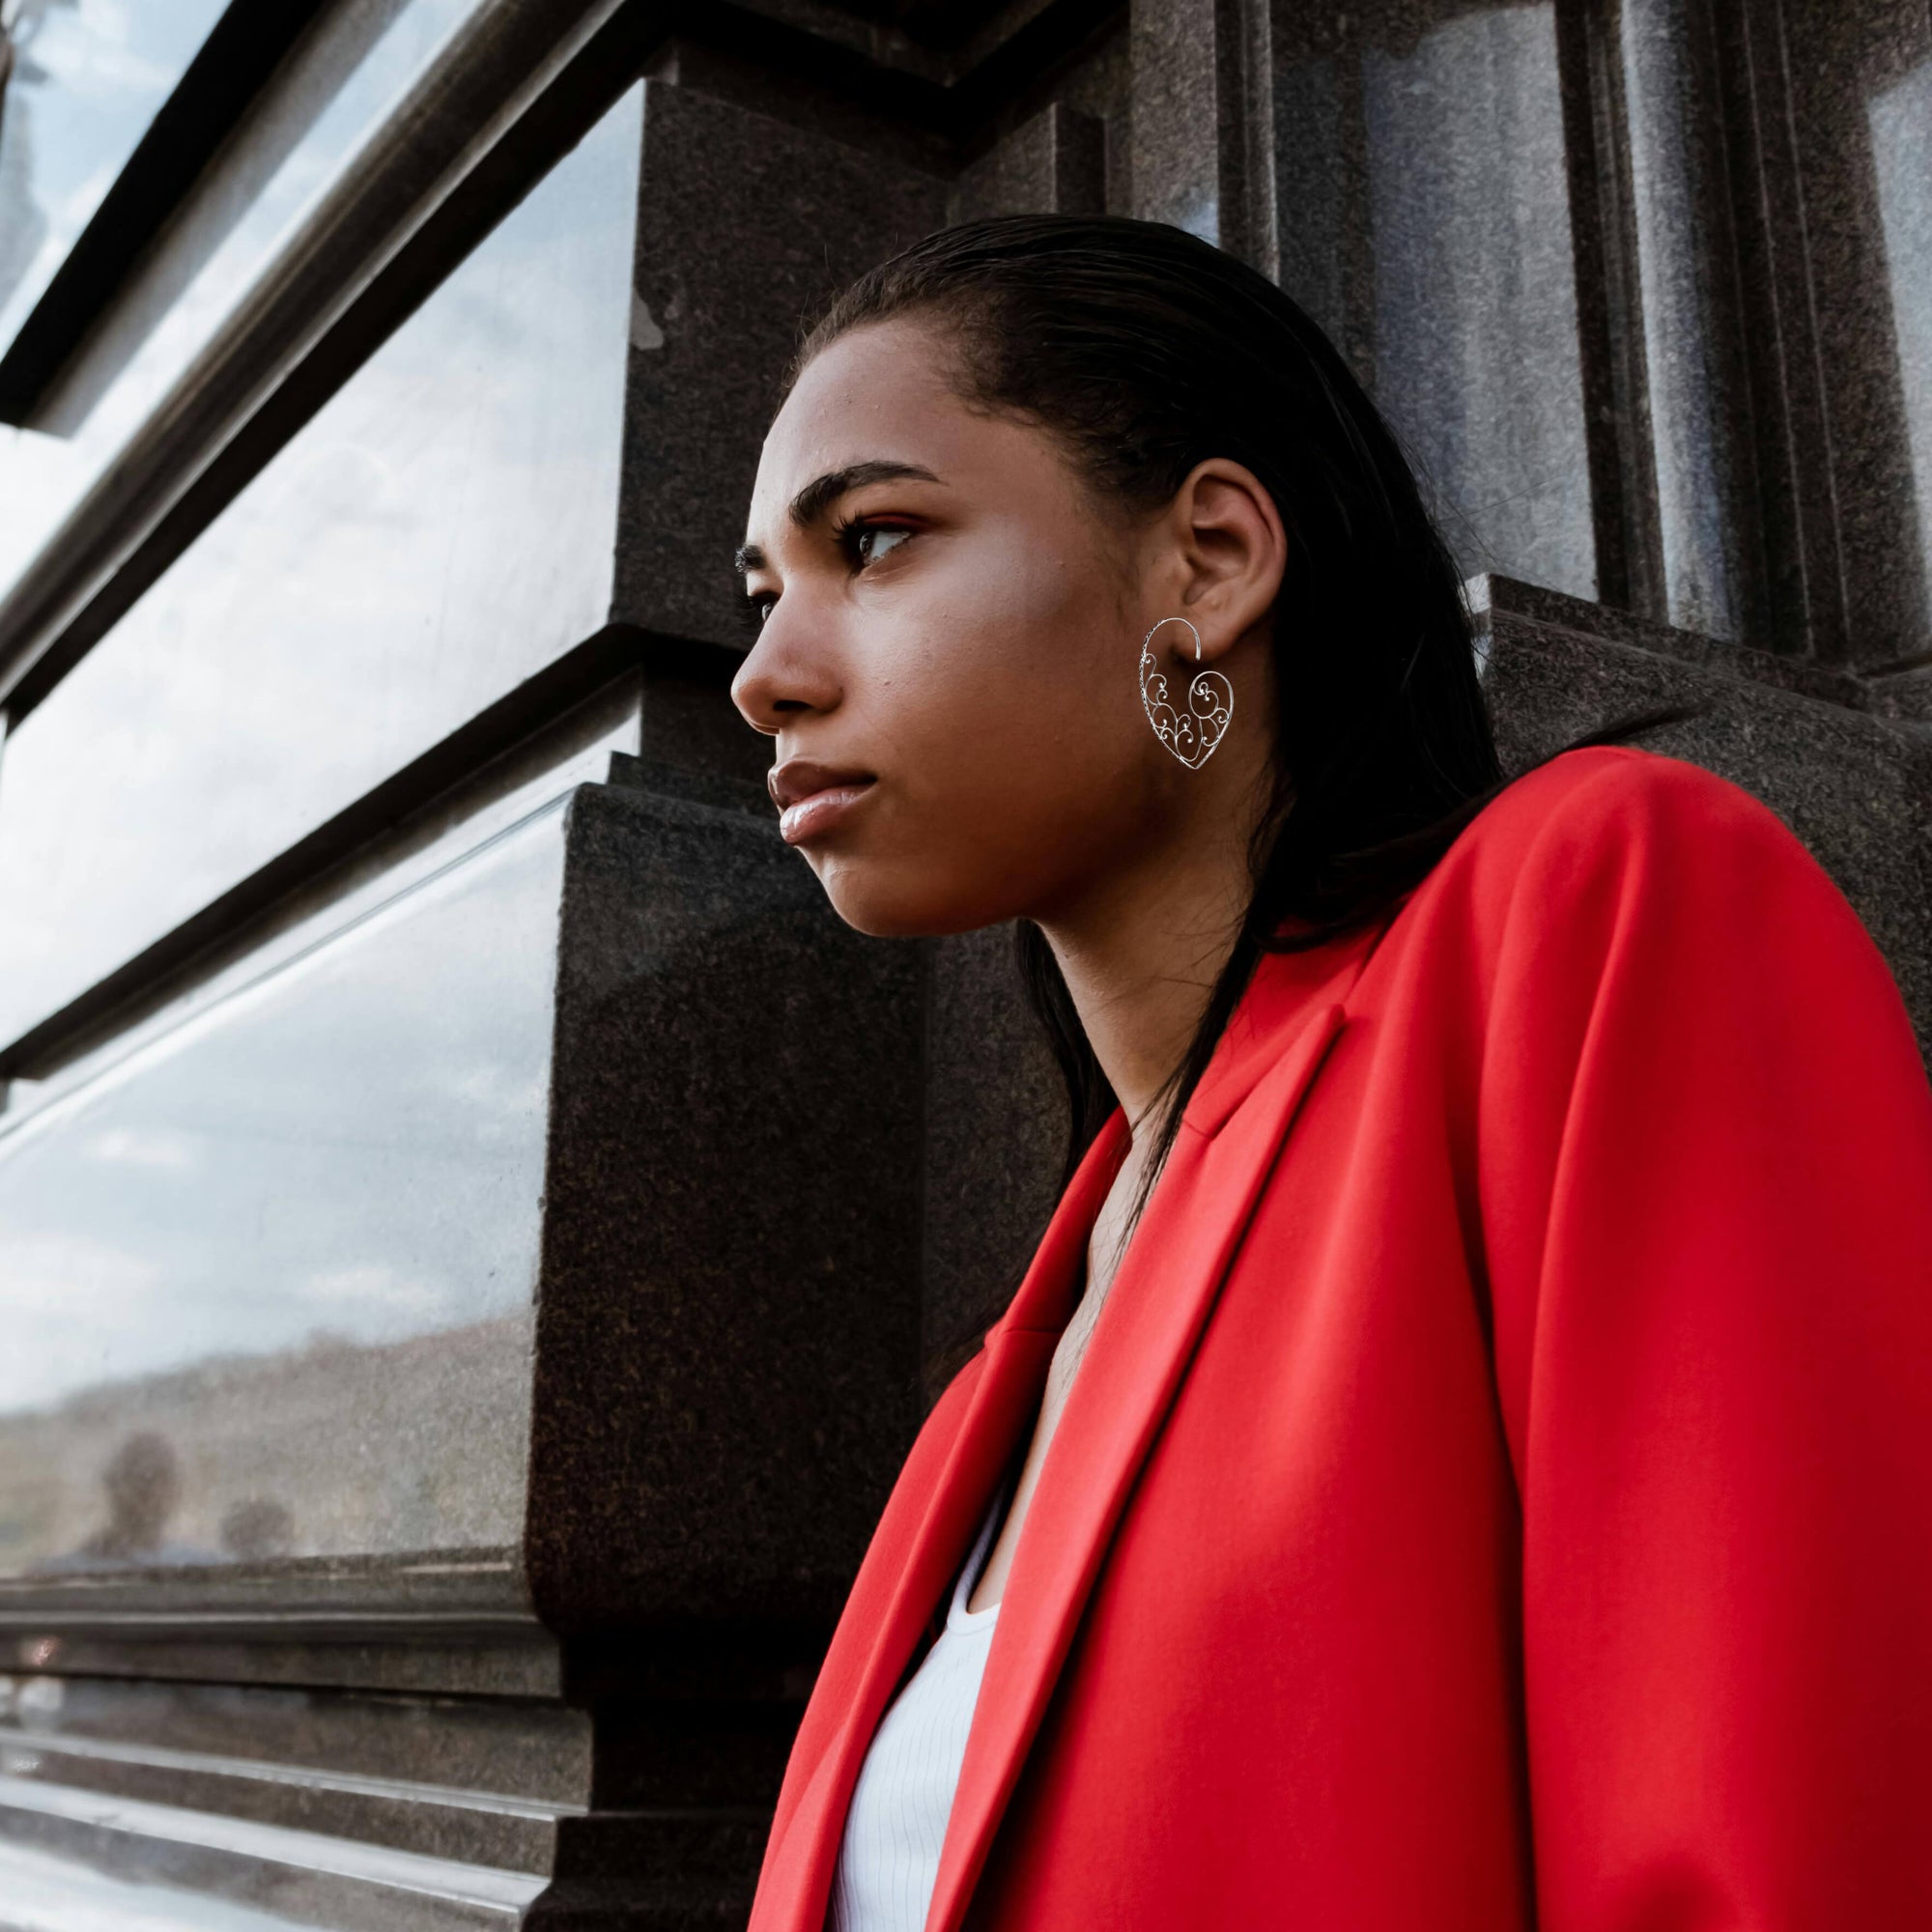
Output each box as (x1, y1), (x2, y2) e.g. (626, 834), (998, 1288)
(752, 748), (1932, 1932)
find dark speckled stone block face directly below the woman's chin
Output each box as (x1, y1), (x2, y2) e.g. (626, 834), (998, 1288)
(527, 777), (920, 1636)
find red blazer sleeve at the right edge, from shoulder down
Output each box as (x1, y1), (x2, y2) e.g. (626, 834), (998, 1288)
(1476, 752), (1932, 1932)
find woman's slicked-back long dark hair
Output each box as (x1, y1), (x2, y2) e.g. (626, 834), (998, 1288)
(792, 214), (1696, 1213)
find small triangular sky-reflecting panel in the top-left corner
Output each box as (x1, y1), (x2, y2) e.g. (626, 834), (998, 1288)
(0, 0), (228, 350)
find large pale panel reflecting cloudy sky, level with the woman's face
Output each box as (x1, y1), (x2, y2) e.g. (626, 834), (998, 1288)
(0, 89), (643, 1039)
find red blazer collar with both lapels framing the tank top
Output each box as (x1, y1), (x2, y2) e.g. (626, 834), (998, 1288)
(753, 923), (1366, 1932)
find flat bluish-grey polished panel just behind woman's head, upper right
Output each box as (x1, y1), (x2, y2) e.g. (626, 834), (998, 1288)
(1275, 0), (1596, 597)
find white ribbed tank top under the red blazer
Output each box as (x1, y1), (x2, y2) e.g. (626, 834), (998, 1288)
(831, 1490), (1007, 1932)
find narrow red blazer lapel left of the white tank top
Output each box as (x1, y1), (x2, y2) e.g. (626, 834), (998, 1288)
(752, 1109), (1128, 1932)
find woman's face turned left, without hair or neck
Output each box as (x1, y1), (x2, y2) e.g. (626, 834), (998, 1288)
(732, 321), (1271, 935)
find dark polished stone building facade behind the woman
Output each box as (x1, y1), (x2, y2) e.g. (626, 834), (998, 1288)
(0, 0), (1932, 1932)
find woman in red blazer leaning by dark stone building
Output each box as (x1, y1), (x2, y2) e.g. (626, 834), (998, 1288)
(734, 218), (1932, 1932)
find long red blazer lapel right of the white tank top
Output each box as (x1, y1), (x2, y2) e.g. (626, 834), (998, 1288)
(923, 997), (1358, 1932)
